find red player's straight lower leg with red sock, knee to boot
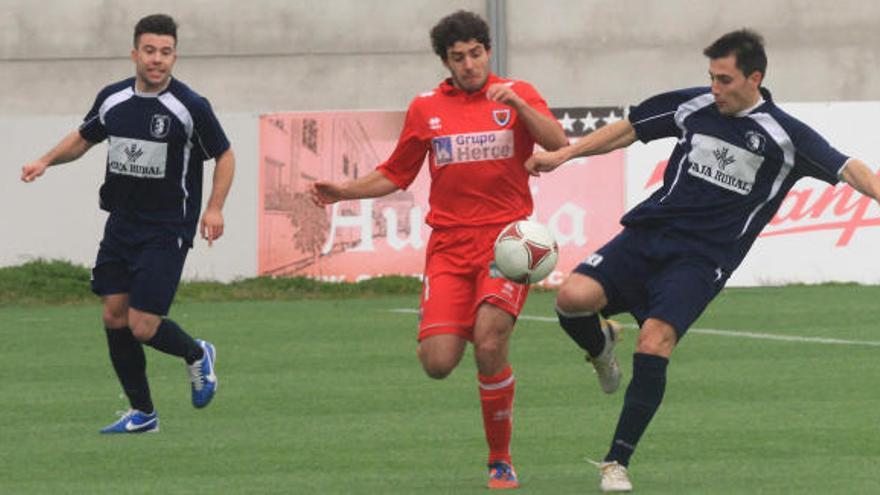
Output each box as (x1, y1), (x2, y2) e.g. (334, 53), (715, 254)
(474, 303), (519, 489)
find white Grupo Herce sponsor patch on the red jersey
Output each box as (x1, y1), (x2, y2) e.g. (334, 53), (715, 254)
(431, 129), (514, 167)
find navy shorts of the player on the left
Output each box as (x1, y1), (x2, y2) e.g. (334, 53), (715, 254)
(92, 215), (190, 316)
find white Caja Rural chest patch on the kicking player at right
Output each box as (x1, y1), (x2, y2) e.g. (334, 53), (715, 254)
(688, 134), (764, 196)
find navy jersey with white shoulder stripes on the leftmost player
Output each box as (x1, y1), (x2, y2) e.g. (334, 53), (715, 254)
(79, 78), (229, 243)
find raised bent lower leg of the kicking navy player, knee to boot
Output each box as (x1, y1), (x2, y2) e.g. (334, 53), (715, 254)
(556, 274), (622, 394)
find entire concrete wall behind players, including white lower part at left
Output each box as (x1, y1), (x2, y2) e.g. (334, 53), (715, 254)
(0, 0), (880, 280)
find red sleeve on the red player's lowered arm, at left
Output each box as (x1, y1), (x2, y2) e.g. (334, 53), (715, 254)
(376, 102), (428, 189)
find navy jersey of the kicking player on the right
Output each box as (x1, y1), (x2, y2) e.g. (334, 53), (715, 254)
(621, 88), (849, 273)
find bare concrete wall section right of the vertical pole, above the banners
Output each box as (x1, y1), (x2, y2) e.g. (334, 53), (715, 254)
(508, 0), (880, 106)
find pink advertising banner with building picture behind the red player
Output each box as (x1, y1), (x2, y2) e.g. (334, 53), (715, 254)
(258, 108), (625, 286)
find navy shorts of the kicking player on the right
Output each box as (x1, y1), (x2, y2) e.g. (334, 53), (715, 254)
(574, 228), (730, 339)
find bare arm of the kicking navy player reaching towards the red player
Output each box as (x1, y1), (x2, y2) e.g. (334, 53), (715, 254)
(525, 119), (638, 176)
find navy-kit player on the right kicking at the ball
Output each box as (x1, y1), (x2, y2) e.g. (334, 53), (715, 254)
(526, 30), (880, 491)
